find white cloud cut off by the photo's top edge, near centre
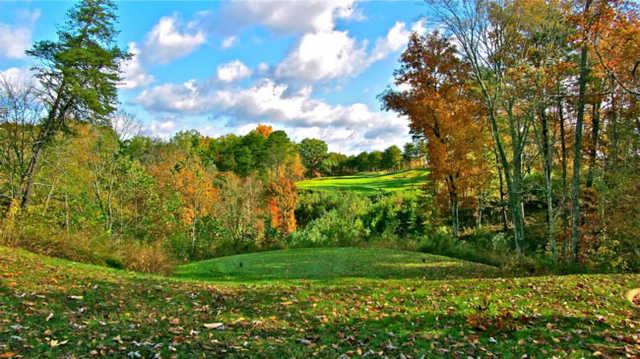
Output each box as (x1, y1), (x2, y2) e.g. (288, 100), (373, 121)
(222, 0), (360, 33)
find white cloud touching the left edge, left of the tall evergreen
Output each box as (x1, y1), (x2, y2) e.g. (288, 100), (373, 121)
(0, 10), (40, 59)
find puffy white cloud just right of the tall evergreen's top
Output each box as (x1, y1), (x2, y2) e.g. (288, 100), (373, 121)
(143, 15), (207, 63)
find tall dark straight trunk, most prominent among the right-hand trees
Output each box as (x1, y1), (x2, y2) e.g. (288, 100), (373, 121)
(571, 38), (590, 262)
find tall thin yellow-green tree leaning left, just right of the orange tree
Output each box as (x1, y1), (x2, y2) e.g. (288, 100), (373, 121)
(428, 0), (535, 254)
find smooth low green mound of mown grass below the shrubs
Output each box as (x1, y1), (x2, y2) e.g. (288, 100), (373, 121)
(177, 248), (498, 282)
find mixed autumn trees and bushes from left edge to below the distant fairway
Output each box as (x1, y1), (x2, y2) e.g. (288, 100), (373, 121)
(0, 116), (432, 272)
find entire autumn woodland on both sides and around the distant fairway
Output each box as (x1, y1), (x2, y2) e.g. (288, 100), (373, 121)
(0, 0), (640, 272)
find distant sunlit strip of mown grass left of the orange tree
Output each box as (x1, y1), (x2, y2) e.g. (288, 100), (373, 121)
(296, 170), (428, 194)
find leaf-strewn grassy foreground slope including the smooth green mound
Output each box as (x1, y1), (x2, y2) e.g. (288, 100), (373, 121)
(0, 247), (640, 358)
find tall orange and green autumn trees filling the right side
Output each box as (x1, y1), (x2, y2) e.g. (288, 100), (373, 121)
(381, 0), (640, 269)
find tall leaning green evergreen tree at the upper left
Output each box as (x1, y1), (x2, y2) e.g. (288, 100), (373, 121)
(19, 0), (128, 208)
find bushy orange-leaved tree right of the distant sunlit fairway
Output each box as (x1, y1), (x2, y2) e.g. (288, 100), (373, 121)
(382, 32), (485, 237)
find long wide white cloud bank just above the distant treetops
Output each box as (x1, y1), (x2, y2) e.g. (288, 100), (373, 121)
(137, 79), (409, 153)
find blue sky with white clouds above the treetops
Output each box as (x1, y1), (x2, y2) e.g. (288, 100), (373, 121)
(0, 0), (429, 154)
